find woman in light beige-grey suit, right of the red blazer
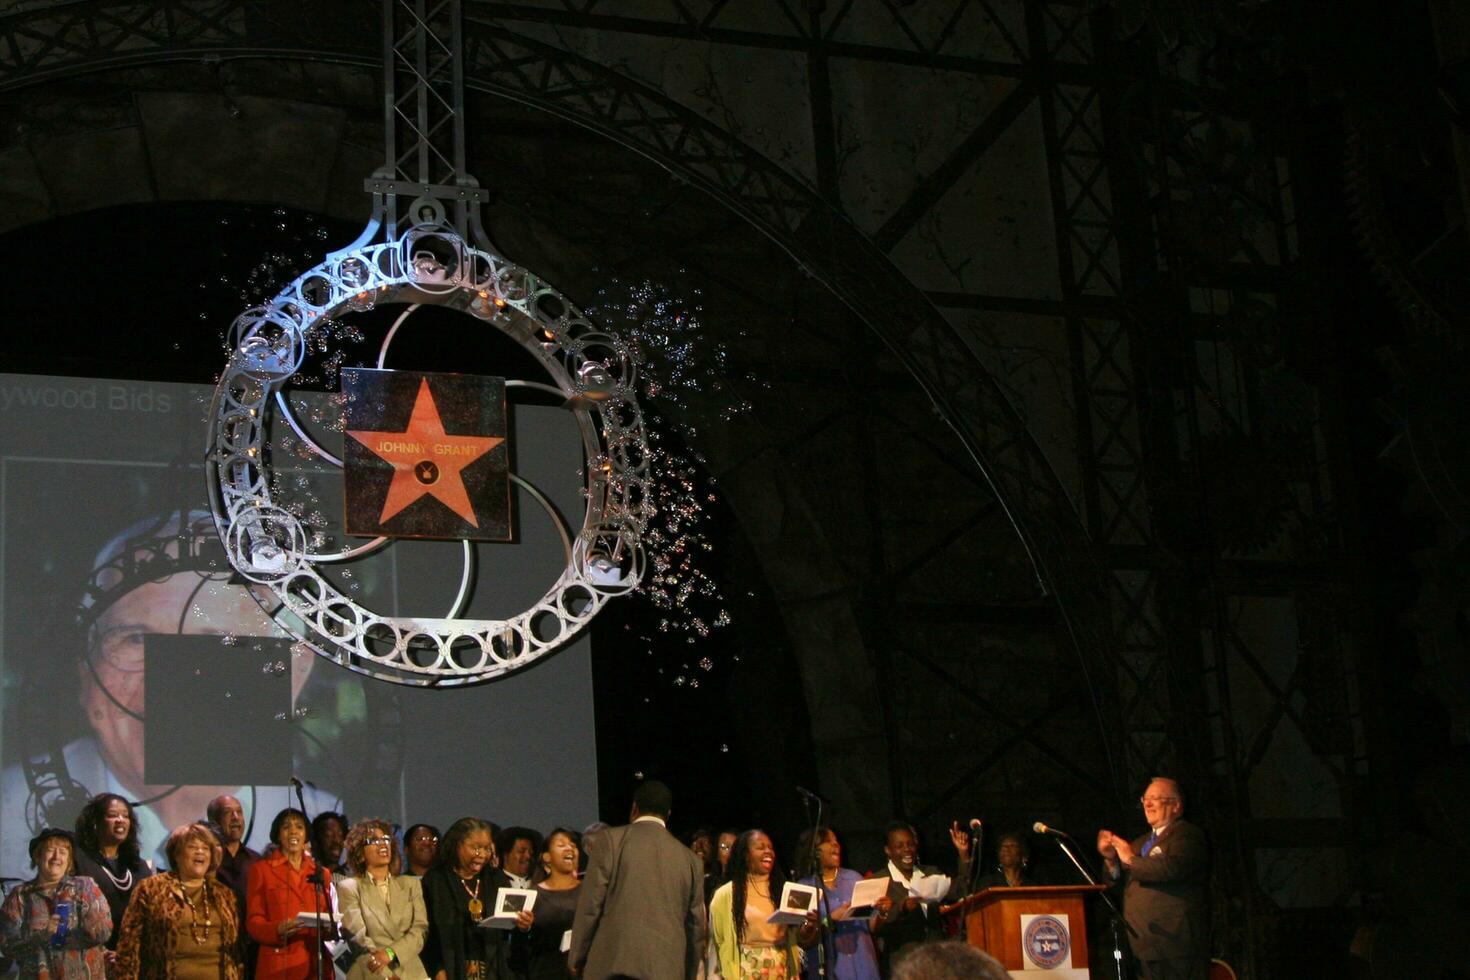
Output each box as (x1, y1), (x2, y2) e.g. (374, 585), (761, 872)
(337, 820), (429, 980)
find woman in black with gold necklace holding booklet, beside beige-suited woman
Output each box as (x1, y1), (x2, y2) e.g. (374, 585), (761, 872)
(423, 817), (535, 980)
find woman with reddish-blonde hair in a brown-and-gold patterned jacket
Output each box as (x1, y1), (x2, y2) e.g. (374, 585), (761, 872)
(110, 823), (245, 980)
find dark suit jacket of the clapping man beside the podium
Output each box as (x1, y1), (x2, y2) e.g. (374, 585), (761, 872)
(1122, 820), (1210, 959)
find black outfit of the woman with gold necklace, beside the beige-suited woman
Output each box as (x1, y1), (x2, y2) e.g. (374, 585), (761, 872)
(422, 865), (514, 980)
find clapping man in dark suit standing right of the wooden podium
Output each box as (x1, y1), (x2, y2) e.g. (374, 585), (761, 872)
(1098, 777), (1210, 980)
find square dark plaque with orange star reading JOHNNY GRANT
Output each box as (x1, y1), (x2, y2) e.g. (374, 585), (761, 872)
(343, 367), (512, 541)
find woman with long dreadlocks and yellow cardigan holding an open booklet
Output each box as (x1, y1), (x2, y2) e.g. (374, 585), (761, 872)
(710, 830), (817, 980)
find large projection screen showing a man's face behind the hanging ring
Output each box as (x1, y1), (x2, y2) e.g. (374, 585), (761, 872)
(0, 375), (597, 879)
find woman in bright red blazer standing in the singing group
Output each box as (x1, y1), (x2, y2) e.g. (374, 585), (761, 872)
(245, 808), (332, 980)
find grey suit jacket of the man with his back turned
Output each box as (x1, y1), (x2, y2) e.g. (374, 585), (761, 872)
(567, 821), (704, 980)
